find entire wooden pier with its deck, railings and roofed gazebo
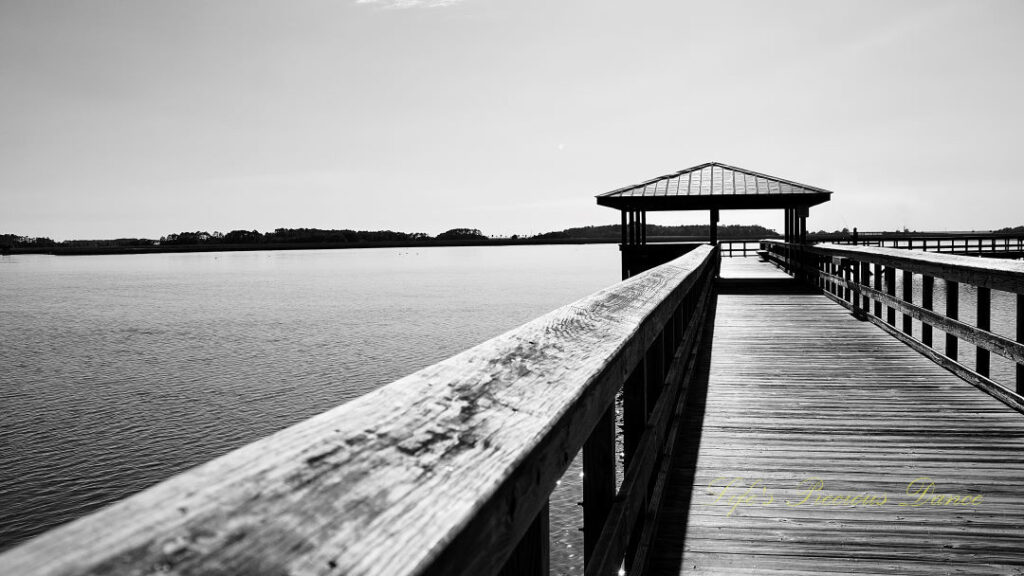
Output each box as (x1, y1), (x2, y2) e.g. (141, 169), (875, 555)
(0, 163), (1024, 576)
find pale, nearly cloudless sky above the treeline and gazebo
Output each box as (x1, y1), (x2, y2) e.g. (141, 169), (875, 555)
(0, 0), (1024, 240)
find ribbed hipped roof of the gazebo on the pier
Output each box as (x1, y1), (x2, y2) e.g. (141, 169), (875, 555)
(597, 162), (831, 211)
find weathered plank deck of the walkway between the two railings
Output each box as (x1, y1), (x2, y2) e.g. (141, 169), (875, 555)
(649, 258), (1024, 575)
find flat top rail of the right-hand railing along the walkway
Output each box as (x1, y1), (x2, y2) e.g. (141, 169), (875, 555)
(764, 240), (1024, 294)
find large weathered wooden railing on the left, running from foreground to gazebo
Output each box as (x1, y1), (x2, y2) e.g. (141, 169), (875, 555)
(0, 246), (719, 576)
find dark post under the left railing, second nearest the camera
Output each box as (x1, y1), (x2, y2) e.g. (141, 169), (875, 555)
(583, 405), (615, 566)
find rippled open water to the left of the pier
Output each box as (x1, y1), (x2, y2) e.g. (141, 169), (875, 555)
(0, 245), (620, 573)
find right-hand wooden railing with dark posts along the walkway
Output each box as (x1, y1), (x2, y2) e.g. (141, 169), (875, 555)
(762, 240), (1024, 412)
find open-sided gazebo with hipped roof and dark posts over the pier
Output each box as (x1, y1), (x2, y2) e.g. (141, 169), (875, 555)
(597, 162), (831, 278)
